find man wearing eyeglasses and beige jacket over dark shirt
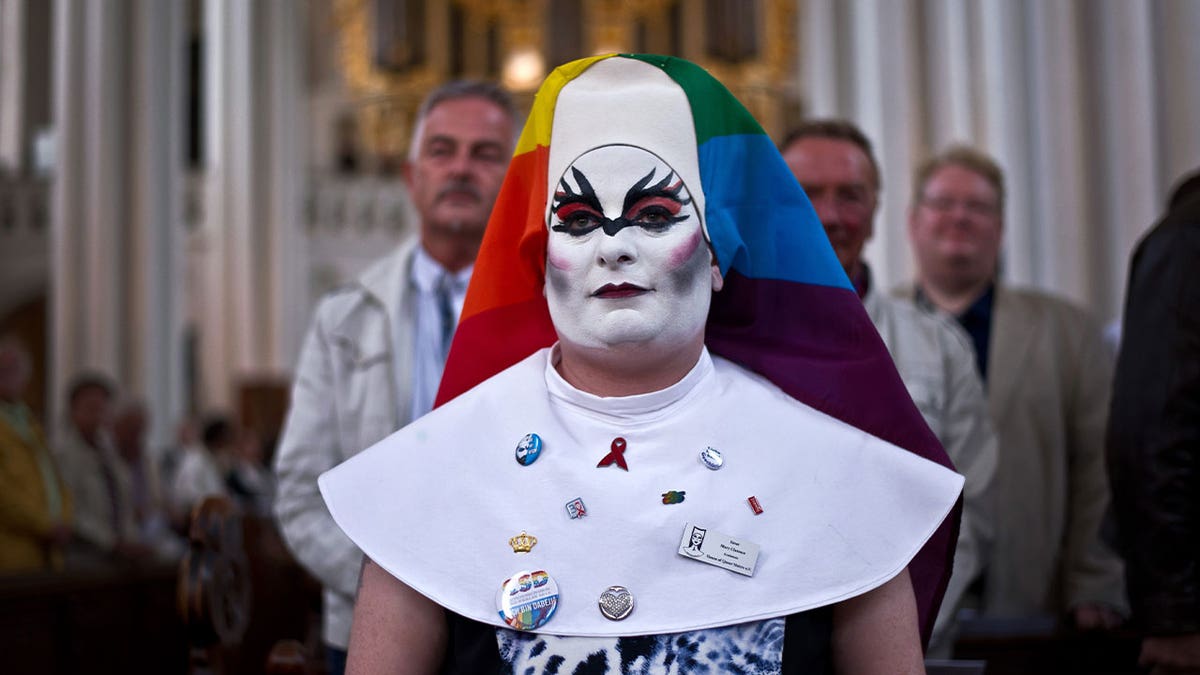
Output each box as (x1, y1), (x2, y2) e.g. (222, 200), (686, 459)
(905, 147), (1128, 628)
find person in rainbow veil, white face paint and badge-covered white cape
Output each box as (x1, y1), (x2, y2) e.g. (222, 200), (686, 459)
(320, 54), (962, 675)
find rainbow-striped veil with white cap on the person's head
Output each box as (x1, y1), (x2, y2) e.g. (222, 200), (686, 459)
(438, 54), (961, 640)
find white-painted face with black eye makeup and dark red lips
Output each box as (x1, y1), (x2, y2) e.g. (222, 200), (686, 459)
(546, 145), (720, 348)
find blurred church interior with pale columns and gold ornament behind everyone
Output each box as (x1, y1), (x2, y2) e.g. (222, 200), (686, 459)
(0, 0), (1200, 667)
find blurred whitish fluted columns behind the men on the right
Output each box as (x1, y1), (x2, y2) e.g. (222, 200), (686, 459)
(800, 0), (1200, 318)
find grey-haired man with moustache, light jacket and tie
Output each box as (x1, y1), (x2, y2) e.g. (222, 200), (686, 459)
(275, 80), (517, 675)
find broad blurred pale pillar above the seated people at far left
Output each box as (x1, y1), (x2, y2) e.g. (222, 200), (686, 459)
(48, 0), (186, 446)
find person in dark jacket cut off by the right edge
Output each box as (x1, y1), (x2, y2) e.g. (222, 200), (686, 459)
(1108, 166), (1200, 673)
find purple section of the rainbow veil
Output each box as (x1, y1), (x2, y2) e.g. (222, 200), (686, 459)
(706, 270), (962, 644)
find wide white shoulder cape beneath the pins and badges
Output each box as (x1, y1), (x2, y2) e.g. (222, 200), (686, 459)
(319, 350), (962, 637)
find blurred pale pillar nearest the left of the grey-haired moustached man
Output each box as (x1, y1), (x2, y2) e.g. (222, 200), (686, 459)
(196, 0), (307, 408)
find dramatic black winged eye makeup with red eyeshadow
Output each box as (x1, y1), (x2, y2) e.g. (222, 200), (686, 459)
(551, 167), (691, 237)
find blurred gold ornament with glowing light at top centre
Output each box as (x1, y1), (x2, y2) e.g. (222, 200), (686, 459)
(335, 0), (800, 166)
